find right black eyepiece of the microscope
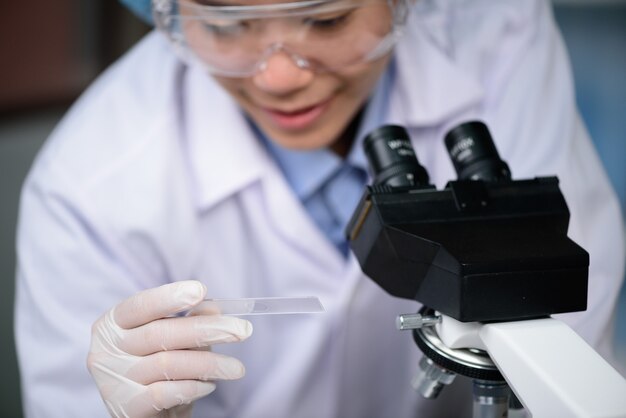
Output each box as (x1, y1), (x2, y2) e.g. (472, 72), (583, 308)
(445, 122), (511, 181)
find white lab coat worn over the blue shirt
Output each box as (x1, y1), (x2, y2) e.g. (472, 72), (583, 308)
(16, 0), (624, 418)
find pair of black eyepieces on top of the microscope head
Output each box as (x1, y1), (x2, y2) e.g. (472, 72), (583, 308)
(363, 121), (511, 187)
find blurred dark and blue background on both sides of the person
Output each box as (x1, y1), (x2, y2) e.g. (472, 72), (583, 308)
(0, 0), (626, 418)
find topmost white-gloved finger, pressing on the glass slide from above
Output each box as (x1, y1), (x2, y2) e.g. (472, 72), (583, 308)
(114, 280), (206, 329)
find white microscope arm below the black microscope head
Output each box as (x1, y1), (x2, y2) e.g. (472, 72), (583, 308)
(456, 318), (626, 418)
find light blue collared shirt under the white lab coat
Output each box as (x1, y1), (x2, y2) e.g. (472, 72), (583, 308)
(255, 60), (395, 257)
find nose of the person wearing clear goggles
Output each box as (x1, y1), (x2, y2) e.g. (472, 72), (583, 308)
(253, 50), (314, 95)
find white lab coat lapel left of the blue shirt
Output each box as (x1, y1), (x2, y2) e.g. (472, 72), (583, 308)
(181, 63), (346, 270)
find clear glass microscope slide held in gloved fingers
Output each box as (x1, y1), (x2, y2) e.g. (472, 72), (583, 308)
(187, 296), (325, 316)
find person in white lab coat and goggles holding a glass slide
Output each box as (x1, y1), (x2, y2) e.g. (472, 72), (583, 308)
(16, 0), (624, 418)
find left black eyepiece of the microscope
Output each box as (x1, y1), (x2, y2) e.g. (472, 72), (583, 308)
(363, 125), (428, 187)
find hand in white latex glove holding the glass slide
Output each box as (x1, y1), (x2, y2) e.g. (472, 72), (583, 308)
(87, 281), (252, 418)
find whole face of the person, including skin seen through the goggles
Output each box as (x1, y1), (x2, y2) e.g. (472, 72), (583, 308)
(180, 0), (391, 154)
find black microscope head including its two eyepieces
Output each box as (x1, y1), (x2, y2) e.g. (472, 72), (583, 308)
(346, 122), (589, 322)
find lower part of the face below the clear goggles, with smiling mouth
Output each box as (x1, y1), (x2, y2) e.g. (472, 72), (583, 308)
(215, 53), (388, 155)
